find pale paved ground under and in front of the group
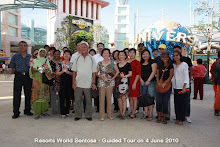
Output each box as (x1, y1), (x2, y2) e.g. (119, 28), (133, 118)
(0, 76), (220, 147)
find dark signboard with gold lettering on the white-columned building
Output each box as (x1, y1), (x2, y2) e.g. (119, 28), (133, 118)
(72, 17), (93, 32)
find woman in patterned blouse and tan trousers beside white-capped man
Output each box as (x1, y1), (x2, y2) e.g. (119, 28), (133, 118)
(97, 48), (119, 121)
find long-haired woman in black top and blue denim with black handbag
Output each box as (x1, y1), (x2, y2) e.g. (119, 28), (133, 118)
(140, 49), (157, 121)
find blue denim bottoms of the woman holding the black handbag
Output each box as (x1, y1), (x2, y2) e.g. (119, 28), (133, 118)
(141, 81), (156, 97)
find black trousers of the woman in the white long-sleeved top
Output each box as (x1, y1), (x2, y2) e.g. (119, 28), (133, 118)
(174, 89), (188, 121)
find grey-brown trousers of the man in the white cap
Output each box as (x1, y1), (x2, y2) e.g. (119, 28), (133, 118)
(74, 87), (93, 118)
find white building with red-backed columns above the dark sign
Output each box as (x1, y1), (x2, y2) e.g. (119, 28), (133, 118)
(47, 0), (109, 47)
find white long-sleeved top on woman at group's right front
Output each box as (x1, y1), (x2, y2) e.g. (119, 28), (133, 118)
(172, 62), (189, 89)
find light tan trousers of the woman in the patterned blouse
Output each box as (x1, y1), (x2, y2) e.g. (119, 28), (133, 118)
(99, 87), (113, 118)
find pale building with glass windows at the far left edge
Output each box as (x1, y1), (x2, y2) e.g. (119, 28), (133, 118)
(0, 9), (31, 64)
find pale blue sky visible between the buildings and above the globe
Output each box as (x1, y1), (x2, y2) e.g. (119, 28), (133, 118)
(21, 0), (218, 41)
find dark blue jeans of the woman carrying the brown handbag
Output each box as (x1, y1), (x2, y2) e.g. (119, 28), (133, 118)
(156, 88), (172, 114)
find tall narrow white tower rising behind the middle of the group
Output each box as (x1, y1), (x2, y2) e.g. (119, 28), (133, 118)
(114, 0), (130, 50)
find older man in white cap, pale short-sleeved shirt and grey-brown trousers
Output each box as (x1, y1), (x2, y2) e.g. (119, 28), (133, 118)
(72, 41), (97, 121)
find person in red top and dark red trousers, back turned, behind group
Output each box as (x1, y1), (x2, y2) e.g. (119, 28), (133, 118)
(193, 59), (206, 100)
